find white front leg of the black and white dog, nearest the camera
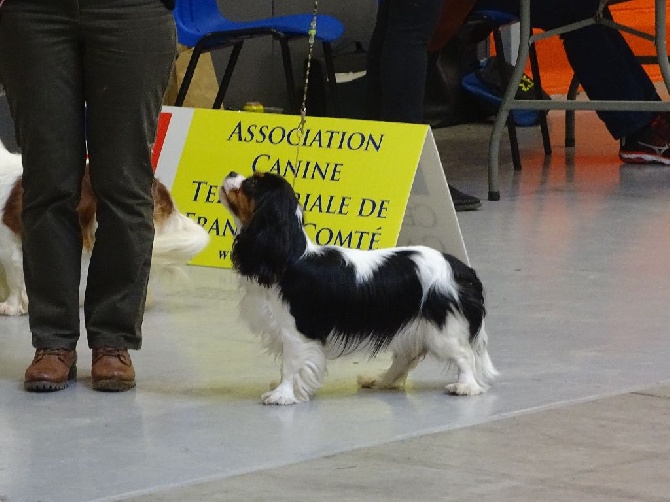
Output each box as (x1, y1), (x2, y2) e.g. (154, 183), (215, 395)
(261, 331), (326, 405)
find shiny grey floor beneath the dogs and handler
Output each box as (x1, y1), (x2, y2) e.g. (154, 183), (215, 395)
(0, 112), (670, 502)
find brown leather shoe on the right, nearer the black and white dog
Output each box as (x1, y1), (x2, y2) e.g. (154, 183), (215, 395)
(91, 347), (135, 392)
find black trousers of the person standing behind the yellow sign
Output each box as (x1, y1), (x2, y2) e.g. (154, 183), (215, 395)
(367, 0), (442, 123)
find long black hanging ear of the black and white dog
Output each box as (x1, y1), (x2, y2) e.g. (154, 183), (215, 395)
(231, 180), (307, 286)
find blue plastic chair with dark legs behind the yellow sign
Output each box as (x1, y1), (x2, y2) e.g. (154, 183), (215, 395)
(173, 0), (344, 115)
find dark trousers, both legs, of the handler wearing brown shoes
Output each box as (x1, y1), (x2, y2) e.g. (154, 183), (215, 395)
(0, 0), (176, 349)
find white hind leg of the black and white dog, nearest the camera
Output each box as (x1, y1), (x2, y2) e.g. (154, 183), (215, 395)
(426, 315), (487, 396)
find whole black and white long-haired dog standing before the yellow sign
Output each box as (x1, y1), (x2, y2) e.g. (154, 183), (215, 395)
(220, 172), (497, 405)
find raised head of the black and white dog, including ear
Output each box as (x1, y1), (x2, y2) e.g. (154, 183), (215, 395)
(220, 172), (307, 286)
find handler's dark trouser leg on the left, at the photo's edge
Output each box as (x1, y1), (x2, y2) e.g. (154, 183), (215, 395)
(0, 0), (85, 349)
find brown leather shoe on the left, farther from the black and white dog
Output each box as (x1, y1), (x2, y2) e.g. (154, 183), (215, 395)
(23, 348), (77, 392)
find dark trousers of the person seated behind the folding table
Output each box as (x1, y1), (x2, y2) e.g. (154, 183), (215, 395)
(476, 0), (661, 139)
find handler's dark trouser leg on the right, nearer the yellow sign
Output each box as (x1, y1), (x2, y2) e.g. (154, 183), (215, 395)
(79, 0), (176, 352)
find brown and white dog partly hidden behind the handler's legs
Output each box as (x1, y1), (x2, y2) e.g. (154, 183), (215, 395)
(0, 142), (209, 316)
